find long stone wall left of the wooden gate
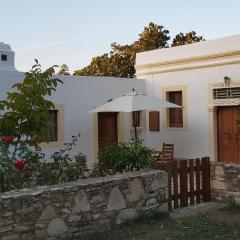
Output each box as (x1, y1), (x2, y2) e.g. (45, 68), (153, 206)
(0, 170), (167, 240)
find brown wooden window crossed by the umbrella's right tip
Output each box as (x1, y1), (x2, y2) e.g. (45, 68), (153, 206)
(167, 91), (183, 128)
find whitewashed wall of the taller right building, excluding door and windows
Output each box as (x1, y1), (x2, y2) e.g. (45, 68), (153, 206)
(136, 35), (240, 157)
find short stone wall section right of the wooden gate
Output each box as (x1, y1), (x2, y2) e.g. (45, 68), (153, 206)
(211, 162), (240, 204)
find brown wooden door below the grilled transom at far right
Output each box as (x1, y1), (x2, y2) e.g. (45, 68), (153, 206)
(218, 107), (240, 163)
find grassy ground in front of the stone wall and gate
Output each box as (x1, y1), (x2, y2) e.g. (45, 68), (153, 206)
(80, 208), (240, 240)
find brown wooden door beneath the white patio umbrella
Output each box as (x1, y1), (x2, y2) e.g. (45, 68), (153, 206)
(98, 112), (118, 151)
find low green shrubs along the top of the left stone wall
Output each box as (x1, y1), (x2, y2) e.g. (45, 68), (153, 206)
(0, 134), (89, 192)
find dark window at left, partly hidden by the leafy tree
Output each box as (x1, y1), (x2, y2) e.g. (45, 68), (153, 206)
(48, 110), (58, 142)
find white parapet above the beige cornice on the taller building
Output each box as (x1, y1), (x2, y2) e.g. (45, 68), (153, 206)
(136, 34), (240, 66)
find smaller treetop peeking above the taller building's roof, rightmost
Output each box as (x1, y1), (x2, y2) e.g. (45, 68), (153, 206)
(171, 31), (205, 47)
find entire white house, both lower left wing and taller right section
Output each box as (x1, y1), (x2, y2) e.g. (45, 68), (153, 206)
(0, 35), (240, 165)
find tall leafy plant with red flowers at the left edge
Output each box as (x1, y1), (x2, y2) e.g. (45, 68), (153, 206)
(0, 60), (62, 191)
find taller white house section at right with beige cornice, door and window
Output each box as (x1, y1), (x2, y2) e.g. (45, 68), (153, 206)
(136, 35), (240, 162)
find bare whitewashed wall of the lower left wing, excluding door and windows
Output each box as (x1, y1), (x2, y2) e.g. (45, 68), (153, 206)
(0, 71), (145, 165)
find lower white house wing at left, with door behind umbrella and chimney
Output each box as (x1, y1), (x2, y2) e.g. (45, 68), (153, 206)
(0, 43), (145, 166)
